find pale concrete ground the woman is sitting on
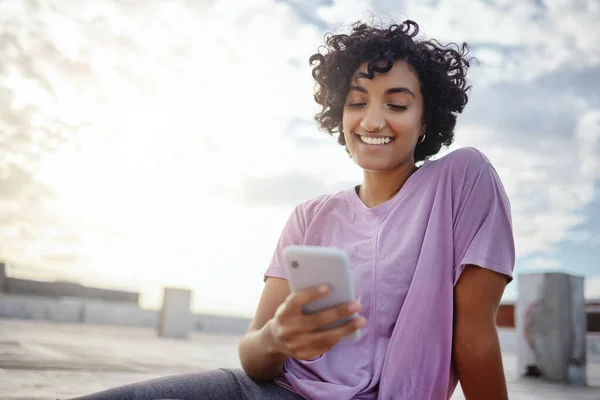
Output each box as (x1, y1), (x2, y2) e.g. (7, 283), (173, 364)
(0, 319), (600, 400)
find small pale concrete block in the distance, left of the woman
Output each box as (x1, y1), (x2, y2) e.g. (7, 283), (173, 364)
(158, 288), (194, 339)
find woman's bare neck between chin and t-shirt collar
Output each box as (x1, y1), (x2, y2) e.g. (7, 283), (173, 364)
(358, 164), (417, 208)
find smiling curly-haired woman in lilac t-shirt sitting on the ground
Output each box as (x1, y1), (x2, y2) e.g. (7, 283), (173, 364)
(72, 21), (514, 400)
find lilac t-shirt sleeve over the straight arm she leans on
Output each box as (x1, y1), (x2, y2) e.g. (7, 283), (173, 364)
(453, 162), (515, 285)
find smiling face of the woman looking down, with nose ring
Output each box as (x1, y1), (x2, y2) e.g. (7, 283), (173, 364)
(342, 61), (425, 171)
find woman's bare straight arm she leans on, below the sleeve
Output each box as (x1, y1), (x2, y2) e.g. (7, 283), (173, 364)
(453, 265), (508, 400)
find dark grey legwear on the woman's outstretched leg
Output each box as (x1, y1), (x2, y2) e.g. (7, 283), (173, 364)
(71, 369), (302, 400)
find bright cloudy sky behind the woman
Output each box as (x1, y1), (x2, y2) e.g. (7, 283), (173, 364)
(0, 0), (600, 316)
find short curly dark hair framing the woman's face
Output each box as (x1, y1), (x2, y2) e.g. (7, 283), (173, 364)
(309, 20), (470, 162)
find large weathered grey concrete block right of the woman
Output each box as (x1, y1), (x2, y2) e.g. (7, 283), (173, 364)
(515, 273), (587, 386)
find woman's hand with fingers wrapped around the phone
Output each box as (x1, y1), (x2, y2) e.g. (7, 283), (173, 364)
(268, 285), (366, 360)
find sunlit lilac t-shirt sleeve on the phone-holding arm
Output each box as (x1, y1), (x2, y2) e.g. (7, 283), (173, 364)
(264, 205), (304, 280)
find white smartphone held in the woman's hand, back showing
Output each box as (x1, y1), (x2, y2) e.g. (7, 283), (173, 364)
(283, 245), (361, 340)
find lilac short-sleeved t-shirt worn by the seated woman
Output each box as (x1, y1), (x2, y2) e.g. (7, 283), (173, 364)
(265, 148), (515, 400)
